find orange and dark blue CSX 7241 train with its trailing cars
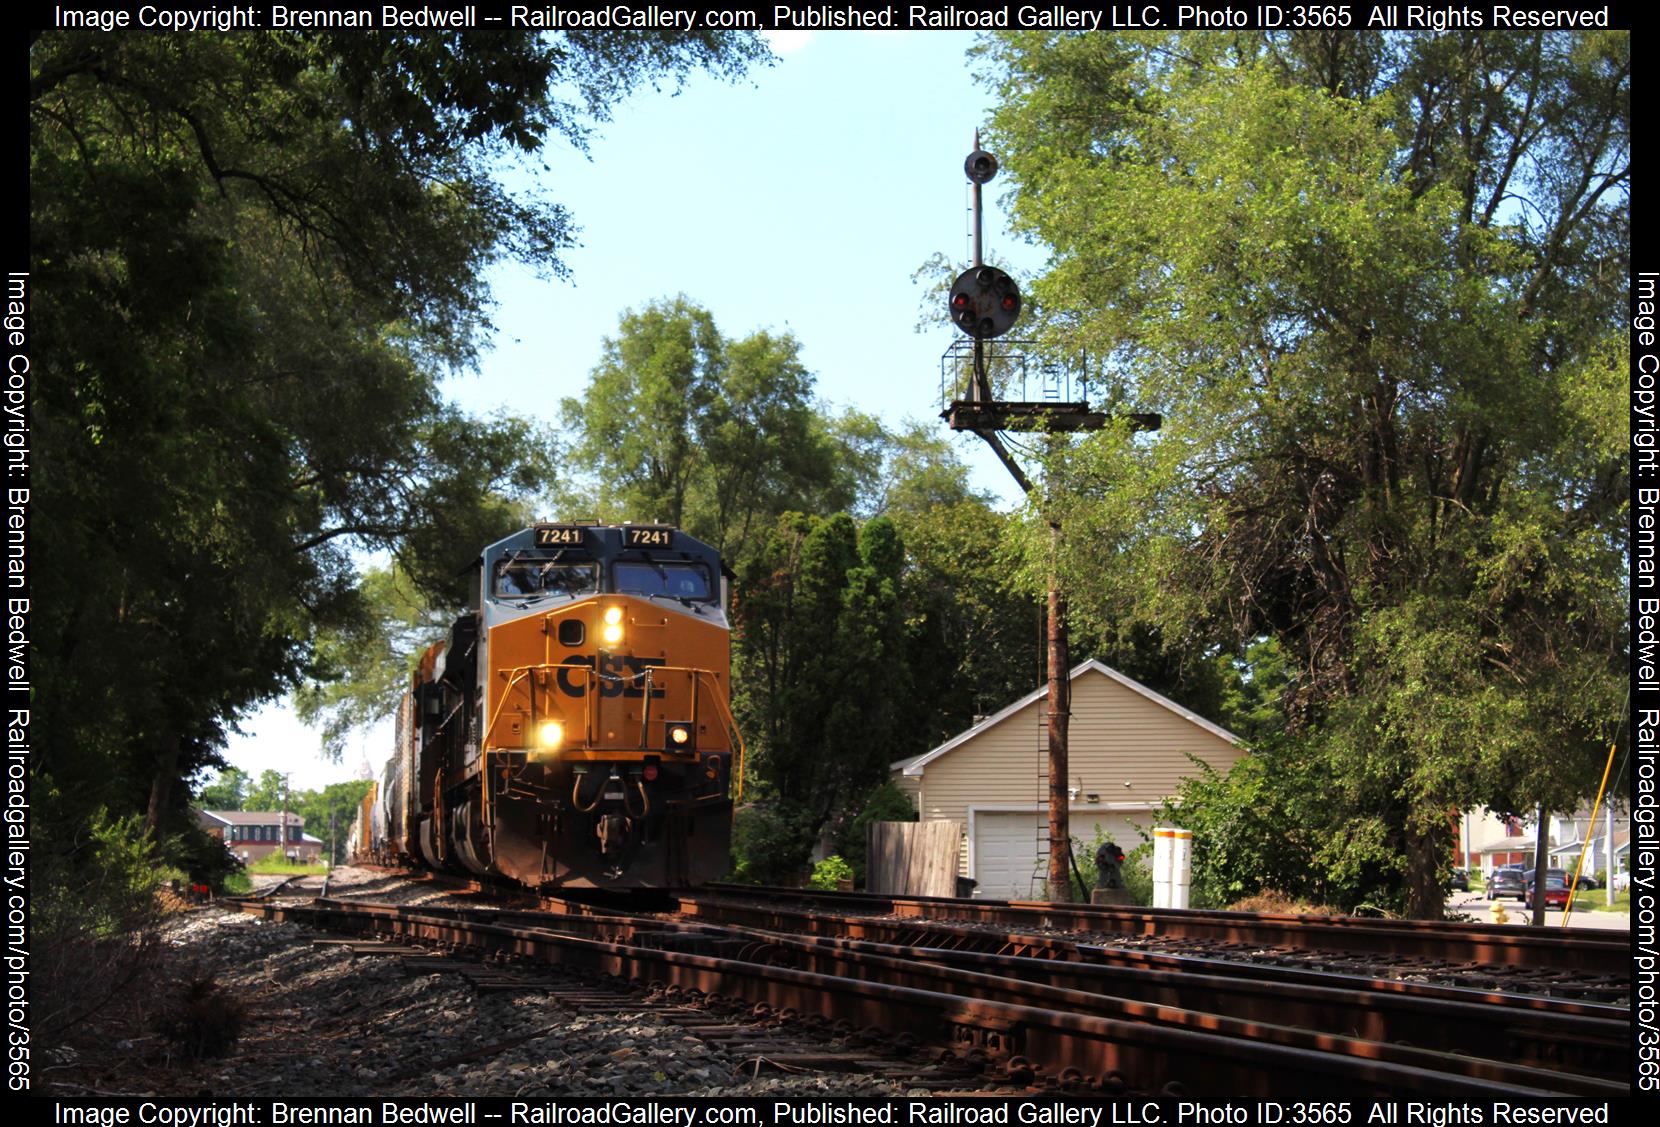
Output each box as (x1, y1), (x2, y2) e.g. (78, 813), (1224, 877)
(357, 523), (742, 890)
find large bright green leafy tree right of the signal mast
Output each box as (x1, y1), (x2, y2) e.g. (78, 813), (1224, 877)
(984, 32), (1630, 916)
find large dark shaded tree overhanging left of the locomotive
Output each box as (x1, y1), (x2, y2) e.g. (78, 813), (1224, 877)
(30, 32), (765, 856)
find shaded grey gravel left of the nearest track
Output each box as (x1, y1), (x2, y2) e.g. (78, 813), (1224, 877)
(46, 868), (905, 1099)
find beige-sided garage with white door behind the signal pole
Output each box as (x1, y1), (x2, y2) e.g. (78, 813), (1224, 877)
(890, 661), (1245, 898)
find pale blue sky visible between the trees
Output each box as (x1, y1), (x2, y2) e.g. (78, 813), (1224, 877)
(227, 32), (1042, 790)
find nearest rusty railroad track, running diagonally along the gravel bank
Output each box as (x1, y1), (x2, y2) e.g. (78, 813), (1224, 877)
(244, 900), (1628, 1099)
